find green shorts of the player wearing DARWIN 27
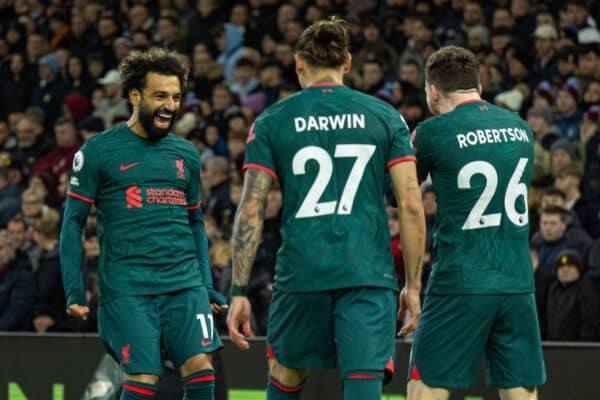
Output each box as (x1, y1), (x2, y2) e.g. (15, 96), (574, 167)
(267, 288), (398, 377)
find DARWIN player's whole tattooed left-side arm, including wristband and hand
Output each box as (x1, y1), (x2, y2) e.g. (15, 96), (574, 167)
(227, 168), (273, 349)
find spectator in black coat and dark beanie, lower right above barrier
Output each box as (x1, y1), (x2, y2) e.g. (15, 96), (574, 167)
(543, 249), (600, 342)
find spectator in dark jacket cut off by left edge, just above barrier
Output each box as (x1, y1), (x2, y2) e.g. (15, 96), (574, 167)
(0, 231), (35, 331)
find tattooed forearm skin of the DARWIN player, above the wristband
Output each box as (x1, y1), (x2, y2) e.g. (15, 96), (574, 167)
(231, 169), (273, 286)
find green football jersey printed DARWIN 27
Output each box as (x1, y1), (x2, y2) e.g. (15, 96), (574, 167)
(244, 83), (415, 292)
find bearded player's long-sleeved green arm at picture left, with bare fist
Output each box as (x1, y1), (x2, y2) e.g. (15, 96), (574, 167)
(60, 196), (92, 319)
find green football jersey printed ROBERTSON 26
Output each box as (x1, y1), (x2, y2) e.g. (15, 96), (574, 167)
(413, 101), (534, 294)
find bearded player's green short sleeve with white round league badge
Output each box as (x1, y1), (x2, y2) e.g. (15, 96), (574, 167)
(67, 142), (101, 204)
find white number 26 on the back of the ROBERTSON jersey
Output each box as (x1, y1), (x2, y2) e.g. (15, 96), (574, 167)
(457, 158), (529, 230)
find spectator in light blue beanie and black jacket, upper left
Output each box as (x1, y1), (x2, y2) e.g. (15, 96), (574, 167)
(31, 53), (67, 128)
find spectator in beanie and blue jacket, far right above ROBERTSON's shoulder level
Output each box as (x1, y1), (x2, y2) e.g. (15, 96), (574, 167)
(555, 79), (583, 142)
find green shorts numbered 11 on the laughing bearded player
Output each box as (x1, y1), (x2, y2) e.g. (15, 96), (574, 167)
(98, 286), (222, 375)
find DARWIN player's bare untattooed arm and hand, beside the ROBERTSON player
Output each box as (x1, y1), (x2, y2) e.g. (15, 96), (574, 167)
(389, 161), (425, 335)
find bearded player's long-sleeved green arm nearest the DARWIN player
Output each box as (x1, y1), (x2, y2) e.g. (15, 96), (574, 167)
(188, 203), (227, 313)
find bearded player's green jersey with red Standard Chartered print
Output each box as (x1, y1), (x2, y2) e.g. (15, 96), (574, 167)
(67, 124), (203, 301)
